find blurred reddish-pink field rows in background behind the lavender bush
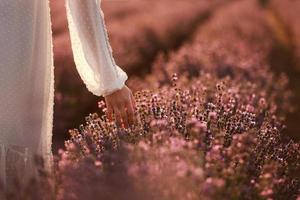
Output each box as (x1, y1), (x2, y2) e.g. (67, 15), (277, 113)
(50, 0), (300, 152)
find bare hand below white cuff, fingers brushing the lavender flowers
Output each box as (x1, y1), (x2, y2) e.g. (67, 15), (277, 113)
(104, 85), (136, 128)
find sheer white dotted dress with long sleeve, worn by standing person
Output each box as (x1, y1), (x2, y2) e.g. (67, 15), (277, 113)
(0, 0), (128, 185)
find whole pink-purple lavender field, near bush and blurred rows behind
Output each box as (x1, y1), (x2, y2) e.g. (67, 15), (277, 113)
(2, 0), (300, 200)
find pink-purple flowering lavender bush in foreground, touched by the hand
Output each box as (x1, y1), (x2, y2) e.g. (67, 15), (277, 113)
(58, 71), (300, 199)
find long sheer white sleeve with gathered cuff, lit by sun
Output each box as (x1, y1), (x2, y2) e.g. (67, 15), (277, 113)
(66, 0), (128, 96)
